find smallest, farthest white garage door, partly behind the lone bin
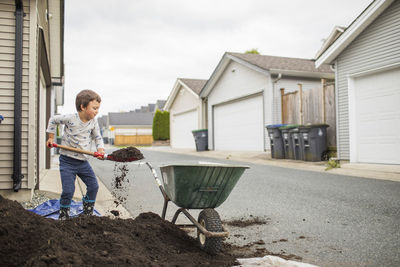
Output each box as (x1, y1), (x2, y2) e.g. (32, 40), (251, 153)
(170, 110), (198, 149)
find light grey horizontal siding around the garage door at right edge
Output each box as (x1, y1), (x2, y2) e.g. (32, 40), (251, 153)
(335, 1), (400, 160)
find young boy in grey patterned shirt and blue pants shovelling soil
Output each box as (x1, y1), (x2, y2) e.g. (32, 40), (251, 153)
(46, 90), (104, 220)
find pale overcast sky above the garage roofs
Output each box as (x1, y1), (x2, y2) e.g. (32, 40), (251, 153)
(62, 0), (372, 114)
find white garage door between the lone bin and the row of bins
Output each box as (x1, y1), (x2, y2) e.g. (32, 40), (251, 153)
(214, 96), (264, 151)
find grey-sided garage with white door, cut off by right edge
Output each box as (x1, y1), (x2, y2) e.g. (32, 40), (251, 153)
(316, 0), (400, 164)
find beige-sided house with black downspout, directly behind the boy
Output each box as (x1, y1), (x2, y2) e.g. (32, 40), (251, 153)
(0, 0), (64, 200)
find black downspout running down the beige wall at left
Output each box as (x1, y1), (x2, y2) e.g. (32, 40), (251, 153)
(11, 0), (25, 192)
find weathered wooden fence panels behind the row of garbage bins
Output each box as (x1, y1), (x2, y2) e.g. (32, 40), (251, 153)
(281, 79), (336, 147)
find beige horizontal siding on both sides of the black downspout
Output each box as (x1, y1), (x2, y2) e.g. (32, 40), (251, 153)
(0, 0), (30, 189)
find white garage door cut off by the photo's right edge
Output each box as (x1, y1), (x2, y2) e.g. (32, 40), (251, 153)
(355, 69), (400, 164)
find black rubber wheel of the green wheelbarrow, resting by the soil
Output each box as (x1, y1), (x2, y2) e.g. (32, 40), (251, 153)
(197, 209), (223, 254)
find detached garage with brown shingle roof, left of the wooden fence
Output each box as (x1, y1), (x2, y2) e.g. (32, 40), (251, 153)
(200, 52), (334, 151)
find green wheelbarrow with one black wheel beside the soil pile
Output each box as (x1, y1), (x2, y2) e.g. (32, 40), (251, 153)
(146, 162), (249, 254)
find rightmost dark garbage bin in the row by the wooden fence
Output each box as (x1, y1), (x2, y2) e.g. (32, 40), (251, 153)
(299, 124), (329, 161)
